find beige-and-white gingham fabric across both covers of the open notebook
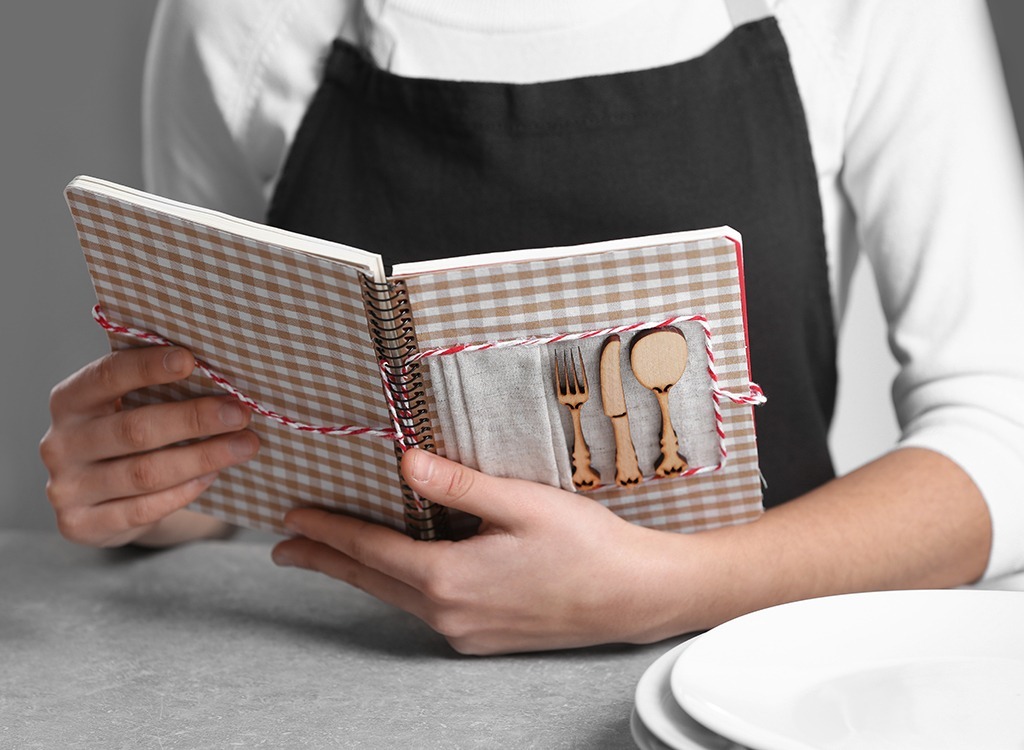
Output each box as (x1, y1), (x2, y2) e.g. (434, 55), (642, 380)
(67, 181), (761, 531)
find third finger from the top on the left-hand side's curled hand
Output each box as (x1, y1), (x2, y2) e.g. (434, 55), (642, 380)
(67, 430), (259, 505)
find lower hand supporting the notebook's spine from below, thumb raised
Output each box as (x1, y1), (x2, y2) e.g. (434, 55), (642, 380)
(273, 450), (687, 654)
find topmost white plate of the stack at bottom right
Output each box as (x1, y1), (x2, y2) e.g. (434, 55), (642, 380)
(670, 590), (1024, 750)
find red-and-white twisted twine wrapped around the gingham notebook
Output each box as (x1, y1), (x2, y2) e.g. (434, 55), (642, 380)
(92, 304), (765, 476)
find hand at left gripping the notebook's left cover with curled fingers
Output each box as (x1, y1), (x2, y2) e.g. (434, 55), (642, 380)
(40, 346), (259, 547)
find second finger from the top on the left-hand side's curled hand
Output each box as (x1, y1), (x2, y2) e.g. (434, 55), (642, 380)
(63, 395), (252, 461)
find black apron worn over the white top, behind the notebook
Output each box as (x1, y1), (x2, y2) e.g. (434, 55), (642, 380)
(268, 17), (836, 507)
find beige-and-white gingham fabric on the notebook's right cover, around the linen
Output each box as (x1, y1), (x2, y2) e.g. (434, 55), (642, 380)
(404, 237), (771, 531)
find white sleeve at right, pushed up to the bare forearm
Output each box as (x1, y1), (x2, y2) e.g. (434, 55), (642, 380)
(843, 0), (1024, 577)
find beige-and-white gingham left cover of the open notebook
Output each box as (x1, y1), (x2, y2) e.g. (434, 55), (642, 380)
(67, 188), (404, 531)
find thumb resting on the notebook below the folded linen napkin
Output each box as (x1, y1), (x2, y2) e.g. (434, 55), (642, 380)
(401, 448), (545, 528)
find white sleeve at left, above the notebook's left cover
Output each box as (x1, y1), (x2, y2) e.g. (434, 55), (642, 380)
(142, 0), (348, 220)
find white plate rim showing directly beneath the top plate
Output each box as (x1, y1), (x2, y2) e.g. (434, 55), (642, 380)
(633, 639), (742, 750)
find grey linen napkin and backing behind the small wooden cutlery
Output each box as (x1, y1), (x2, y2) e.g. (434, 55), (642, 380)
(426, 324), (724, 491)
